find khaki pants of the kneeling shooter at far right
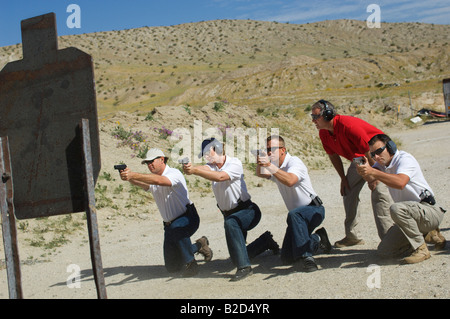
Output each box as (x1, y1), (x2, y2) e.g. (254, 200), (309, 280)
(378, 201), (444, 257)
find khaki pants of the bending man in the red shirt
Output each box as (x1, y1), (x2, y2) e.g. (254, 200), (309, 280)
(343, 162), (394, 240)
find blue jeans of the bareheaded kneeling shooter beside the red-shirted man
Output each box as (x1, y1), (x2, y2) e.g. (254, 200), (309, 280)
(281, 206), (325, 264)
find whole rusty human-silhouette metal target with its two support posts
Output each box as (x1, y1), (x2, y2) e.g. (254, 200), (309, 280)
(0, 13), (107, 299)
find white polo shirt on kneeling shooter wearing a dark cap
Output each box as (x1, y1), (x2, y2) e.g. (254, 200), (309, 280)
(207, 156), (251, 210)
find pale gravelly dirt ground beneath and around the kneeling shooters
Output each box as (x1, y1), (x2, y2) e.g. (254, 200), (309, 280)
(0, 122), (450, 299)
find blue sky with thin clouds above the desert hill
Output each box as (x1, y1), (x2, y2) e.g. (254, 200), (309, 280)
(0, 0), (450, 47)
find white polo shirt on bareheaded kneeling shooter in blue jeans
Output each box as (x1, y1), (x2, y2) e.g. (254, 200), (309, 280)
(270, 153), (317, 211)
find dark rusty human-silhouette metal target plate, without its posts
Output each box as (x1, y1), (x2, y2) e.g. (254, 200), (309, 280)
(0, 13), (100, 219)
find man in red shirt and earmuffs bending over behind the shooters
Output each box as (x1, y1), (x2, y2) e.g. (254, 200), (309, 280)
(311, 100), (393, 248)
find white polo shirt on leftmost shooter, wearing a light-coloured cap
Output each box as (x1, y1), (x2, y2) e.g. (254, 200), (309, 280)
(148, 165), (192, 222)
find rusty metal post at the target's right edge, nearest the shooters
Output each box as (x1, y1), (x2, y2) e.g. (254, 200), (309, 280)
(81, 119), (107, 299)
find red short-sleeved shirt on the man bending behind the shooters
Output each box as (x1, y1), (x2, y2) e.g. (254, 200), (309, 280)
(319, 115), (383, 161)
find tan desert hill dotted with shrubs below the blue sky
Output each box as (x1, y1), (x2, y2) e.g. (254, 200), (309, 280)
(0, 20), (450, 115)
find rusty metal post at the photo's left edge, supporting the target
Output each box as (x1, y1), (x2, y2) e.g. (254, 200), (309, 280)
(0, 137), (23, 299)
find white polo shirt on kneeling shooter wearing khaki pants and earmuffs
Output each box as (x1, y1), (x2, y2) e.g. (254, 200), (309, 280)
(373, 151), (434, 202)
